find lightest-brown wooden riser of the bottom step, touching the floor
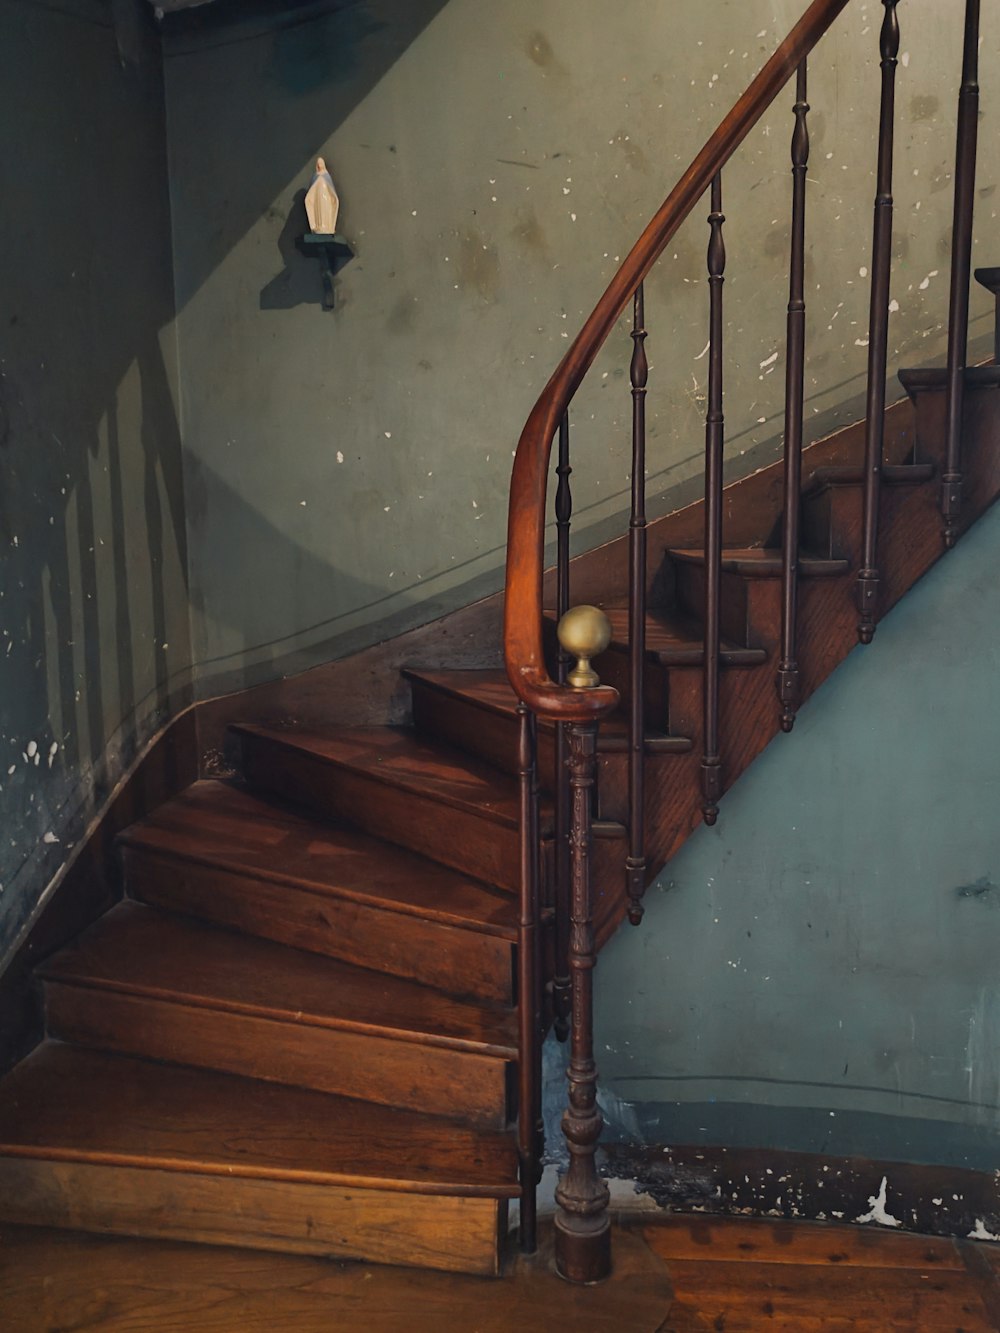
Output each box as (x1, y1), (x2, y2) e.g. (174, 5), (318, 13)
(0, 1157), (505, 1277)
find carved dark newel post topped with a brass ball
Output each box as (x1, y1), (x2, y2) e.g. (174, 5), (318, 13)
(556, 607), (611, 1282)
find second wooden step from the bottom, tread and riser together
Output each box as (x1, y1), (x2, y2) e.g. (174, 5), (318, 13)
(39, 902), (517, 1128)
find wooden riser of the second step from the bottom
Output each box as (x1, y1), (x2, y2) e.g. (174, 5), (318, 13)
(45, 981), (508, 1129)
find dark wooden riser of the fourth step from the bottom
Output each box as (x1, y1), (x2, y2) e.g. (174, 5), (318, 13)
(241, 734), (520, 893)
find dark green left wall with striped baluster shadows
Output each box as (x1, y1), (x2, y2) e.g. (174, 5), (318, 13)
(0, 0), (191, 966)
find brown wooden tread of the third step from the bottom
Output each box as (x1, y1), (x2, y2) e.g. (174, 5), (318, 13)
(120, 781), (517, 940)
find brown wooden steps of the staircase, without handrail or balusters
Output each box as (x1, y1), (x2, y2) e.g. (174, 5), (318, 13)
(0, 343), (1000, 1273)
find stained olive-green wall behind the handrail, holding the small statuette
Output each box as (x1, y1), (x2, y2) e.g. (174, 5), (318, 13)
(165, 0), (1000, 692)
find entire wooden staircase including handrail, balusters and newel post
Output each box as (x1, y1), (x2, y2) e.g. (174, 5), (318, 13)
(0, 0), (1000, 1281)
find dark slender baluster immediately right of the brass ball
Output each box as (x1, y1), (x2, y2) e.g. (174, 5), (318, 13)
(625, 283), (649, 925)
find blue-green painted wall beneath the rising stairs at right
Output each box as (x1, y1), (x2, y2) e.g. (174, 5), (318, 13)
(596, 509), (1000, 1170)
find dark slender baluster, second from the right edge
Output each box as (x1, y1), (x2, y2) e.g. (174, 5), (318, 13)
(857, 0), (899, 644)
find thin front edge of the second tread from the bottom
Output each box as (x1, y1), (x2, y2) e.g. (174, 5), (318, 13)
(36, 970), (517, 1061)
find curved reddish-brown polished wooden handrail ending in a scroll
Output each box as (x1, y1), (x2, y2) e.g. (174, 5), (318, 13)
(504, 0), (849, 722)
